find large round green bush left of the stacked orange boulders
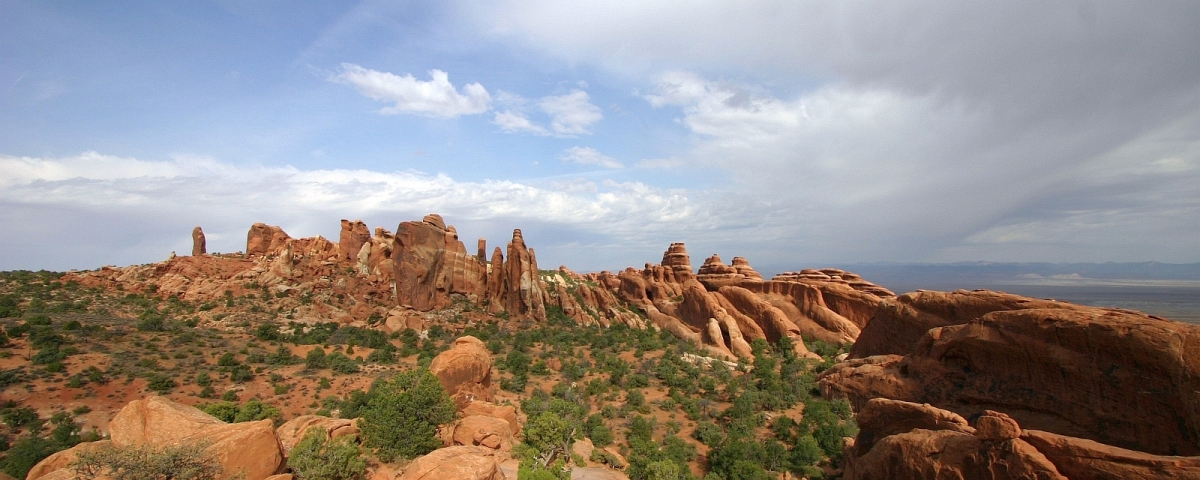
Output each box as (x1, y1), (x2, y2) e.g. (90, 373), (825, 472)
(359, 368), (455, 461)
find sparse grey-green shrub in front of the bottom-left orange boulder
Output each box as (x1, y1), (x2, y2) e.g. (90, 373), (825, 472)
(70, 444), (222, 480)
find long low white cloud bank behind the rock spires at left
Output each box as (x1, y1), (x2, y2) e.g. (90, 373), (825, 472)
(0, 152), (722, 269)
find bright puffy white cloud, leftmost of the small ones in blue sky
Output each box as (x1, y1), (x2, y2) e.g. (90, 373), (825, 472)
(330, 64), (492, 118)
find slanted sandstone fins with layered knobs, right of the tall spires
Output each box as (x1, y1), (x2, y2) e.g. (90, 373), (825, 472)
(604, 244), (892, 358)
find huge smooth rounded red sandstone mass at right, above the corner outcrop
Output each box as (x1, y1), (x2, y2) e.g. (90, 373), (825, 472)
(820, 293), (1200, 455)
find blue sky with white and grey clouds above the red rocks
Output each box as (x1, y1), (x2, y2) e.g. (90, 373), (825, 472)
(0, 0), (1200, 272)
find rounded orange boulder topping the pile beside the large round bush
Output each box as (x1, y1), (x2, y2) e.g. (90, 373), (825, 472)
(430, 335), (494, 410)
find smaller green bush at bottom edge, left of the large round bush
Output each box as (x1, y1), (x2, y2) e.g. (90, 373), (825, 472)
(288, 427), (367, 480)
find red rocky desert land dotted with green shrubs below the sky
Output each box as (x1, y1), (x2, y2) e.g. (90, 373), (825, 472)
(0, 215), (1200, 479)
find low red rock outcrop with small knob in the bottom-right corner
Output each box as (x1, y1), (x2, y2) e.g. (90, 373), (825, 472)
(844, 398), (1200, 479)
